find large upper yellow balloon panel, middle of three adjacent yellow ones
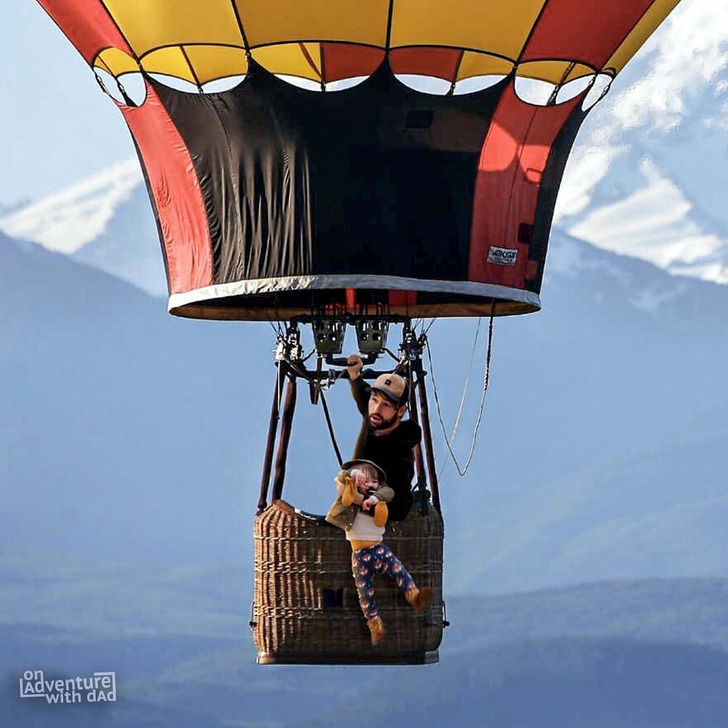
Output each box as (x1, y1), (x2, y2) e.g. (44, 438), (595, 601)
(236, 0), (389, 48)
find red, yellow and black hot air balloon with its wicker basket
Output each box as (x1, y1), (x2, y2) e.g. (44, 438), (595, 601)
(39, 0), (678, 663)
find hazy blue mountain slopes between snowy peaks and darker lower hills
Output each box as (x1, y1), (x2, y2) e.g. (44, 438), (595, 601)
(0, 229), (728, 593)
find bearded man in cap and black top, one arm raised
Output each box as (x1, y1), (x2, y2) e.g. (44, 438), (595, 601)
(347, 354), (422, 521)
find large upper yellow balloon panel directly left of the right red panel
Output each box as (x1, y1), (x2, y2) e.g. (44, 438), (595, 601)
(391, 0), (544, 61)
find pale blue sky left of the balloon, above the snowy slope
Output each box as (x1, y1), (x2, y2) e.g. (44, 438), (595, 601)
(0, 0), (134, 205)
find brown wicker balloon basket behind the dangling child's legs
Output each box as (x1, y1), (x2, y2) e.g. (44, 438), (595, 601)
(251, 500), (444, 664)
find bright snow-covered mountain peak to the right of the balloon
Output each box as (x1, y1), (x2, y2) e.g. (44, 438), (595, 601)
(555, 2), (728, 283)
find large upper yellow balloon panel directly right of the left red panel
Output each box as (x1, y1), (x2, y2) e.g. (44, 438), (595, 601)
(105, 0), (243, 56)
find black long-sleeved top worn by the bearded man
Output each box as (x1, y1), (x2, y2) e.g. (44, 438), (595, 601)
(350, 377), (422, 521)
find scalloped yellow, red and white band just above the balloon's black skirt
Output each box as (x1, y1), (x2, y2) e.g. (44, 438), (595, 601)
(93, 43), (613, 111)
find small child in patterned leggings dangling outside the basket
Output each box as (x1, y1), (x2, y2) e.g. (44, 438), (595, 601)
(326, 460), (432, 645)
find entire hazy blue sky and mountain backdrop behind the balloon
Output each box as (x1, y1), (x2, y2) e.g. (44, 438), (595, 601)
(0, 0), (728, 728)
